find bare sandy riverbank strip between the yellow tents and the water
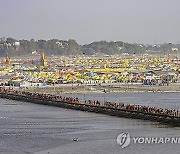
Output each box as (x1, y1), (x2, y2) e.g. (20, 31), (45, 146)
(19, 83), (180, 94)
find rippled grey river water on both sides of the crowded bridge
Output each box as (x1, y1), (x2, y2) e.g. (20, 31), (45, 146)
(0, 93), (180, 154)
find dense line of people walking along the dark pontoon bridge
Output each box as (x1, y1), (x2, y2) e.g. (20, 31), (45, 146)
(0, 87), (180, 117)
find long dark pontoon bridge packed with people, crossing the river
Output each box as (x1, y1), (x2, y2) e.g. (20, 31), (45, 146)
(0, 87), (180, 127)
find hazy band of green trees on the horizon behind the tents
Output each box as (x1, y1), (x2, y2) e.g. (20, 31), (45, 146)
(0, 38), (180, 56)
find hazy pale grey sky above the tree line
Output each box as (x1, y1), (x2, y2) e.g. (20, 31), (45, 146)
(0, 0), (180, 44)
